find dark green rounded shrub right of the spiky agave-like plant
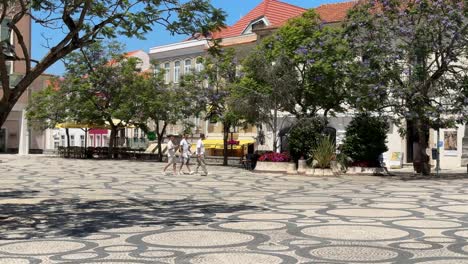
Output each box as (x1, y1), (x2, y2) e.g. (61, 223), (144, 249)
(342, 113), (389, 166)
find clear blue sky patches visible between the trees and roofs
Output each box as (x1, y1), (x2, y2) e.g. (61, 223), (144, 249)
(32, 0), (344, 75)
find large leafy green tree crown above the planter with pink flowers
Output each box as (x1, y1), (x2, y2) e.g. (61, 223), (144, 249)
(260, 10), (352, 119)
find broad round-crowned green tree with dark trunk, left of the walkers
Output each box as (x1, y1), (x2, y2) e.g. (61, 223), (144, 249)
(61, 42), (144, 155)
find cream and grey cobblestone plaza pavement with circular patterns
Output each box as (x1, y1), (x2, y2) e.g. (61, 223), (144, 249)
(0, 156), (468, 264)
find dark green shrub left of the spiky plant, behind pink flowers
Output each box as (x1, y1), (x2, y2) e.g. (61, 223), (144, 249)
(288, 118), (325, 161)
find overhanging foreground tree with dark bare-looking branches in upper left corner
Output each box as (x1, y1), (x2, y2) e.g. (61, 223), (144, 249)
(0, 0), (225, 126)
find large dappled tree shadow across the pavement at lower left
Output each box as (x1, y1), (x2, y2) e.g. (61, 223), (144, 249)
(0, 199), (264, 239)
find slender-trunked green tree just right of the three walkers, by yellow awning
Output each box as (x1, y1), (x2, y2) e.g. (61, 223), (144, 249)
(232, 49), (298, 152)
